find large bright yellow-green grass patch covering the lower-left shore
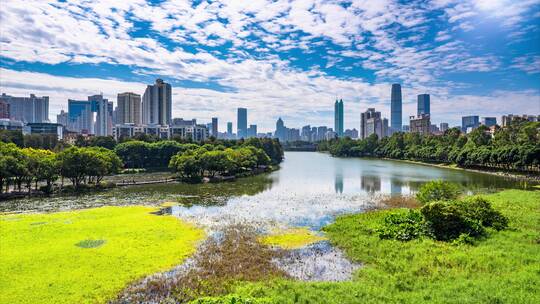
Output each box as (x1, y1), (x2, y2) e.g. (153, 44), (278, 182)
(0, 206), (204, 304)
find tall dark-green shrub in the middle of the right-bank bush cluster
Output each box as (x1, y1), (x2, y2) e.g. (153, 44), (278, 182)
(420, 201), (485, 241)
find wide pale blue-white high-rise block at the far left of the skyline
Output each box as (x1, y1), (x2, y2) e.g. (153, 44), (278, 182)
(0, 93), (49, 123)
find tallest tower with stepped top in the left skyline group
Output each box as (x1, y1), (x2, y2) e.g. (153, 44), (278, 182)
(142, 79), (172, 125)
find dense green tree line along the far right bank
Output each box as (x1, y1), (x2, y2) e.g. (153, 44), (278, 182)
(318, 122), (540, 172)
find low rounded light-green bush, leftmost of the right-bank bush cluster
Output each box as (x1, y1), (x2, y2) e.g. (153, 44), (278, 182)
(377, 209), (426, 241)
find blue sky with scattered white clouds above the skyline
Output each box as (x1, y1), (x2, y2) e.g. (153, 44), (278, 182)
(0, 0), (540, 131)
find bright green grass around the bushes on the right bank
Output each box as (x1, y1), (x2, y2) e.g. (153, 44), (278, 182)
(199, 190), (540, 304)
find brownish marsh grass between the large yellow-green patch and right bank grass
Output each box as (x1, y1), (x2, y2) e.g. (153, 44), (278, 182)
(113, 225), (287, 303)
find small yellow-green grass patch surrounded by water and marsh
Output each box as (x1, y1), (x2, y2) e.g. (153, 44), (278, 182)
(260, 228), (327, 249)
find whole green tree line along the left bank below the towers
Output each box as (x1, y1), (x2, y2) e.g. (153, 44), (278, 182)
(0, 137), (283, 193)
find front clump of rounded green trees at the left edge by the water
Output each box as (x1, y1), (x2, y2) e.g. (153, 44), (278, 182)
(0, 142), (122, 193)
